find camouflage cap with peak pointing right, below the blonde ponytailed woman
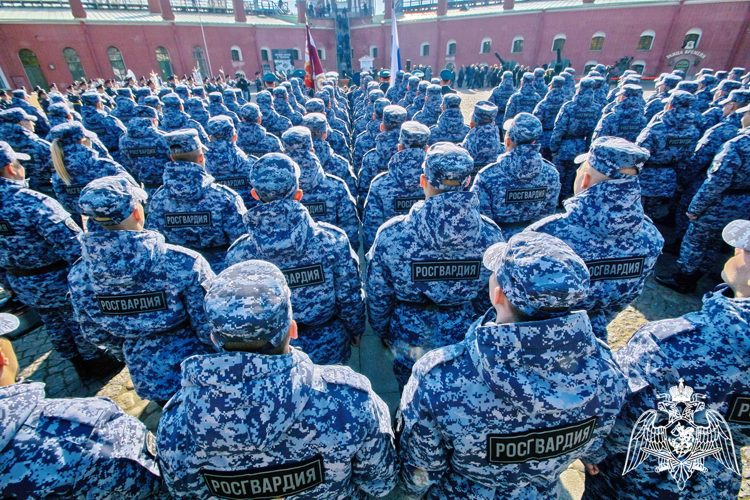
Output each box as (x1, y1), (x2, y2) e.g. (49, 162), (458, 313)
(78, 175), (148, 227)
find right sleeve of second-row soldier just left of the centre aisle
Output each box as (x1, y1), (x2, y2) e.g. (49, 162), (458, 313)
(333, 234), (365, 338)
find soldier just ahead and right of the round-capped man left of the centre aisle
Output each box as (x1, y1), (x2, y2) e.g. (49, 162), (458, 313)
(281, 127), (359, 252)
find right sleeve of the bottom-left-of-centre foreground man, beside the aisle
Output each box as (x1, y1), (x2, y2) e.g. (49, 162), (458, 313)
(352, 391), (398, 497)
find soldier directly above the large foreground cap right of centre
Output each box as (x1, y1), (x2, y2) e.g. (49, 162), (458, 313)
(471, 113), (560, 238)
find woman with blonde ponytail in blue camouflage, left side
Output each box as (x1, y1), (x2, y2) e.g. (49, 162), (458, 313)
(50, 122), (135, 227)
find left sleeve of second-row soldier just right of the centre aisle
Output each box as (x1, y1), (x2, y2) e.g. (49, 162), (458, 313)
(365, 235), (396, 339)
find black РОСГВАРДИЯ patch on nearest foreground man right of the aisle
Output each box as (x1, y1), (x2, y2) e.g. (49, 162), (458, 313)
(487, 417), (596, 464)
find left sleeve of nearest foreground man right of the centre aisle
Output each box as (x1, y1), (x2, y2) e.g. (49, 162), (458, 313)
(398, 370), (450, 498)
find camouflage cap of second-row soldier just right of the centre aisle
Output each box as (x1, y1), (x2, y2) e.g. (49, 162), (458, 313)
(422, 142), (474, 191)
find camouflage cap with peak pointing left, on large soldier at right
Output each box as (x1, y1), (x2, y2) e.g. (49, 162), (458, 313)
(575, 136), (651, 179)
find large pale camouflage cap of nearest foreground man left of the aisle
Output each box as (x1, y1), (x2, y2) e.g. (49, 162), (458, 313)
(203, 260), (292, 347)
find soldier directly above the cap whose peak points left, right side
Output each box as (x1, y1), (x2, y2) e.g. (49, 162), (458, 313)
(592, 84), (648, 142)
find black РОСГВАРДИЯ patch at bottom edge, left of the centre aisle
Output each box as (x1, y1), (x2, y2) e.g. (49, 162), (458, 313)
(201, 455), (325, 500)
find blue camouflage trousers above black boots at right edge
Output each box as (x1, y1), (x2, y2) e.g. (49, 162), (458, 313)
(677, 194), (750, 274)
